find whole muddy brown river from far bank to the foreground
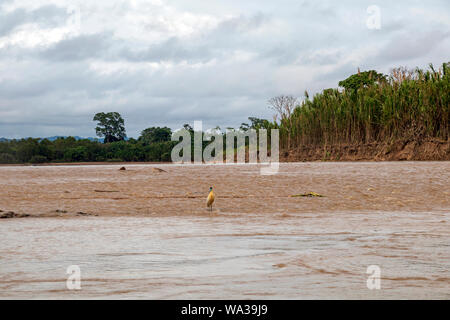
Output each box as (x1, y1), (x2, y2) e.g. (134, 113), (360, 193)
(0, 162), (450, 299)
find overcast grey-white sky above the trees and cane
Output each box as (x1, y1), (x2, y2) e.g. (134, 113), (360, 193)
(0, 0), (450, 138)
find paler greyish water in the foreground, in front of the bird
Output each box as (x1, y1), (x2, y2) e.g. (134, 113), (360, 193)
(0, 211), (450, 299)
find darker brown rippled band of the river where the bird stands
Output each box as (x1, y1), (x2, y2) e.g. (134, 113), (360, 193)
(0, 162), (450, 217)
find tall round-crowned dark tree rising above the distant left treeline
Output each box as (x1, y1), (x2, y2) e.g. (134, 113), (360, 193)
(94, 112), (127, 143)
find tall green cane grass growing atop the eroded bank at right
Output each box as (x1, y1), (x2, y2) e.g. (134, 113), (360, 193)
(280, 63), (450, 148)
